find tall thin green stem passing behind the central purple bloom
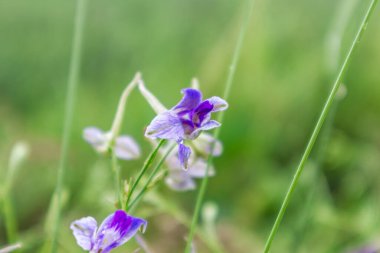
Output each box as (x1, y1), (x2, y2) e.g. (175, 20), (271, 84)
(185, 0), (255, 253)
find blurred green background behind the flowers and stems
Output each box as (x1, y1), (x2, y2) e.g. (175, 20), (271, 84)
(0, 0), (380, 253)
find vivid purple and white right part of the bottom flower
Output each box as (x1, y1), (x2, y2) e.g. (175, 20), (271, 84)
(94, 210), (147, 253)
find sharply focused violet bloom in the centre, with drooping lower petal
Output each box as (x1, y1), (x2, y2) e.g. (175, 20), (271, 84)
(145, 88), (228, 169)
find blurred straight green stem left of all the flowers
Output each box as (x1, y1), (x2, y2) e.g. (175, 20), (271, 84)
(51, 0), (87, 252)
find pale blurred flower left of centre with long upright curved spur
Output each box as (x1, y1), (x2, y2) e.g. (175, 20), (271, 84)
(83, 73), (141, 160)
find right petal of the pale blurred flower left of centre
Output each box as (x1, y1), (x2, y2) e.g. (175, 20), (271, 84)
(115, 135), (140, 160)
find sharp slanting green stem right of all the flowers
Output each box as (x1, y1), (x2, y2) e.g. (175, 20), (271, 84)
(264, 0), (378, 253)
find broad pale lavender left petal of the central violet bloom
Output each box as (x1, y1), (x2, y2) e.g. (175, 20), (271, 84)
(145, 111), (184, 140)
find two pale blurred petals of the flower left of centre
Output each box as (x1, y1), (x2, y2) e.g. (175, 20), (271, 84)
(83, 127), (140, 160)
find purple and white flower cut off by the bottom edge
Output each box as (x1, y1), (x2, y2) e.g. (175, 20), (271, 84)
(70, 210), (147, 253)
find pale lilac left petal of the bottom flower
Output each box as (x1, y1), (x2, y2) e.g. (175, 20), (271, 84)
(70, 217), (98, 250)
